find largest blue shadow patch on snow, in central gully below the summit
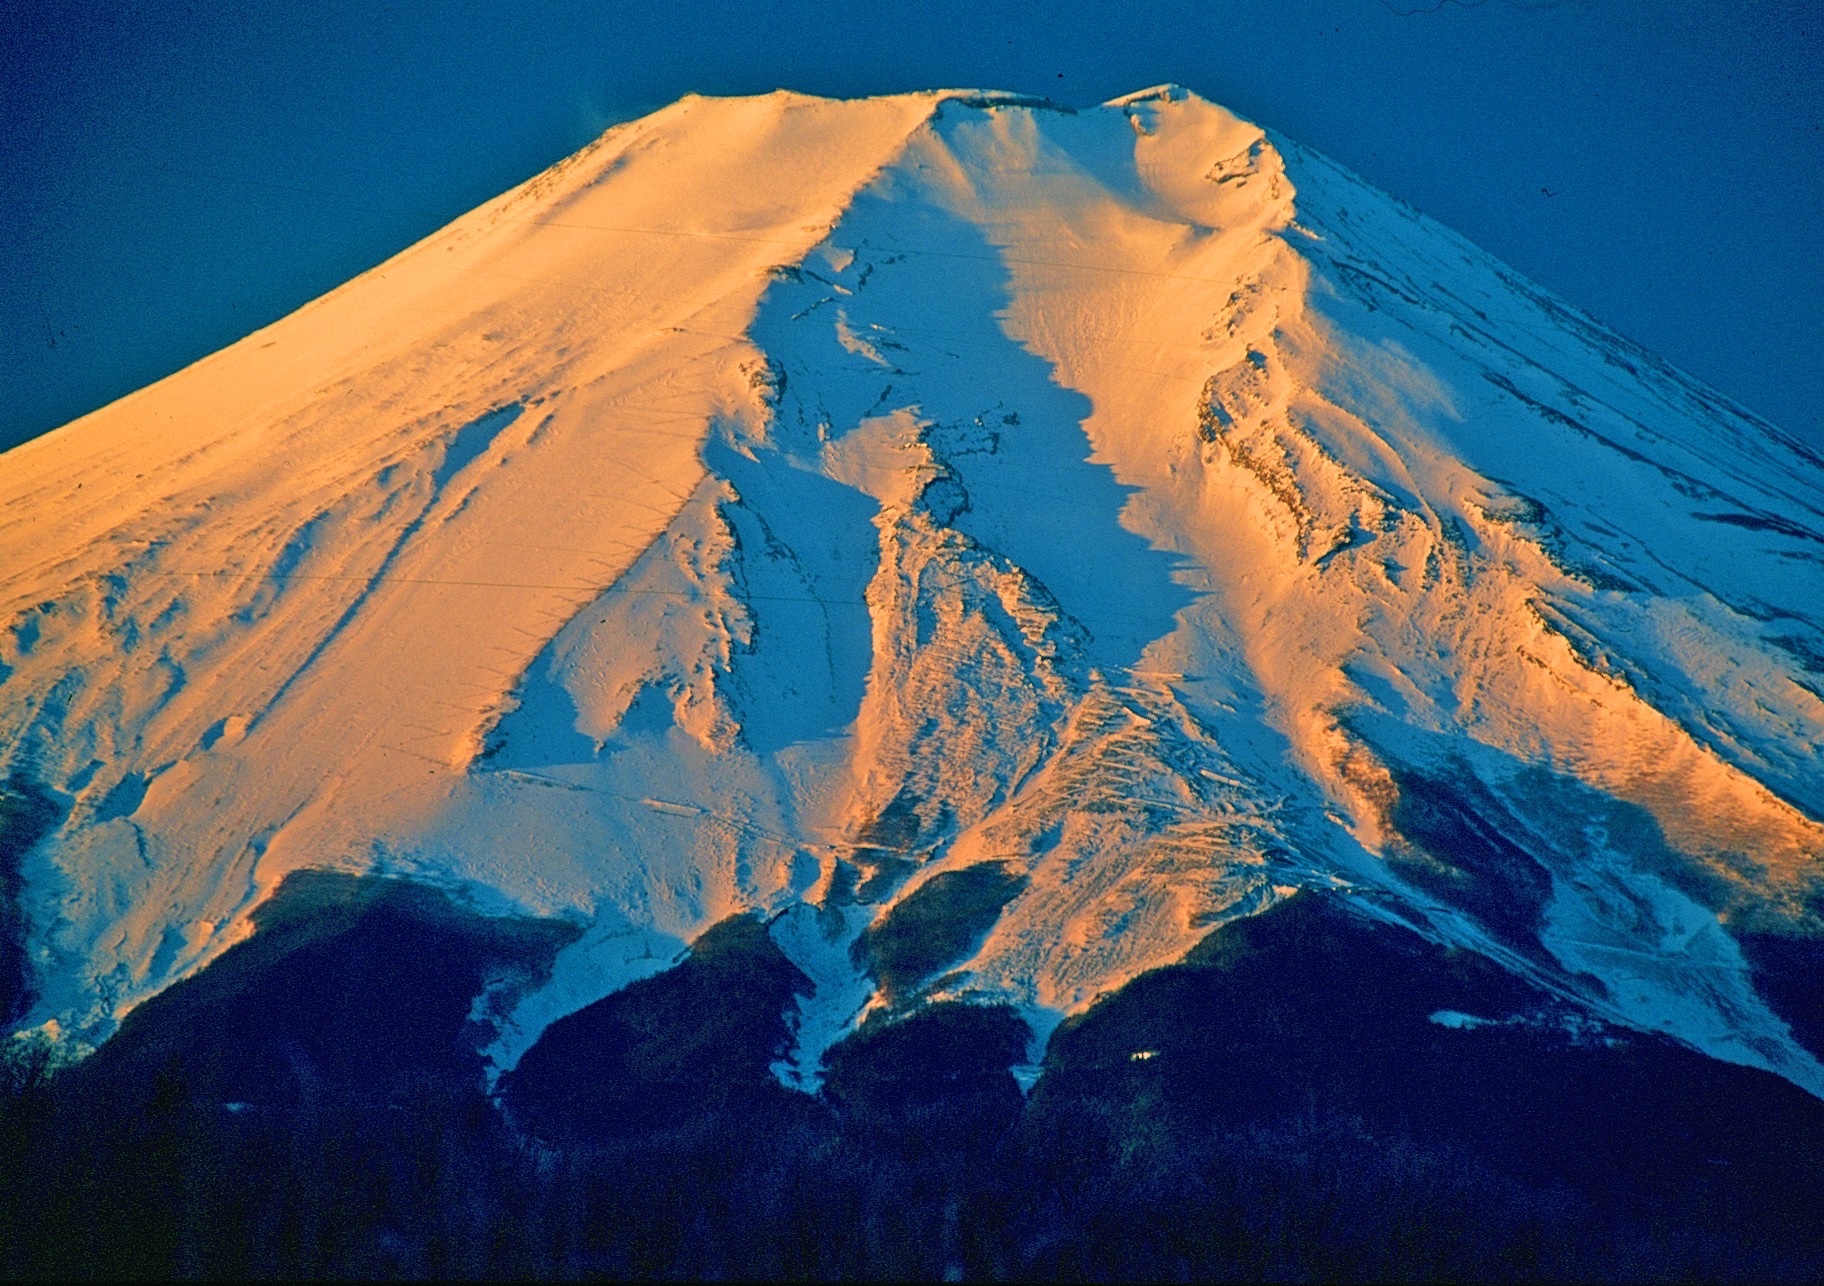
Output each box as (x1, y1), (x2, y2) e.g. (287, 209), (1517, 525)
(787, 189), (1191, 669)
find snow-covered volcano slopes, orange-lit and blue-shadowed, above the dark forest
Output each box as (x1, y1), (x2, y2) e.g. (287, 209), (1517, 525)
(0, 88), (1824, 1094)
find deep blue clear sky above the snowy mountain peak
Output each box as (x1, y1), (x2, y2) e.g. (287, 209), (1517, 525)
(0, 0), (1824, 447)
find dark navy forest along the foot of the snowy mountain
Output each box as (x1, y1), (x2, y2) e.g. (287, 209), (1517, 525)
(0, 876), (1824, 1281)
